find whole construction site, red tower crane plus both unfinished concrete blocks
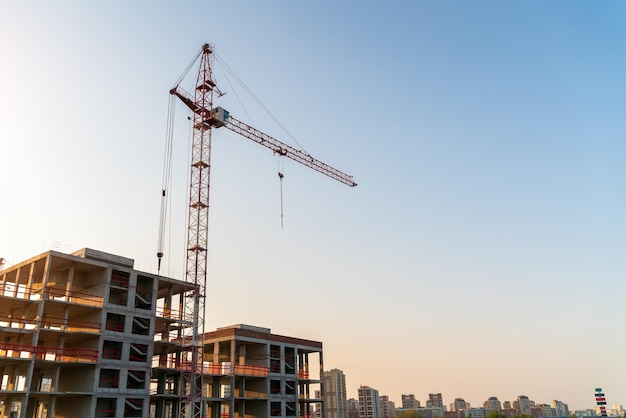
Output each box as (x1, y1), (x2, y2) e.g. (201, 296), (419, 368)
(0, 44), (356, 418)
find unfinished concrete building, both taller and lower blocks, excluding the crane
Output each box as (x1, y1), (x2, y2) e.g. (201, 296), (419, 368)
(0, 249), (323, 418)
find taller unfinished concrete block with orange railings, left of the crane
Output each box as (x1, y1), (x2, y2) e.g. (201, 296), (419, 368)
(0, 249), (185, 418)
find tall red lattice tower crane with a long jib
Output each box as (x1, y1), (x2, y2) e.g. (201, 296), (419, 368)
(157, 44), (357, 418)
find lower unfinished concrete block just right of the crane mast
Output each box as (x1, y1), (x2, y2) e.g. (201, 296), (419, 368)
(194, 324), (326, 418)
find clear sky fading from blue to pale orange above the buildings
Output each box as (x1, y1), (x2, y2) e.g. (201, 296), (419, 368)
(0, 0), (626, 409)
